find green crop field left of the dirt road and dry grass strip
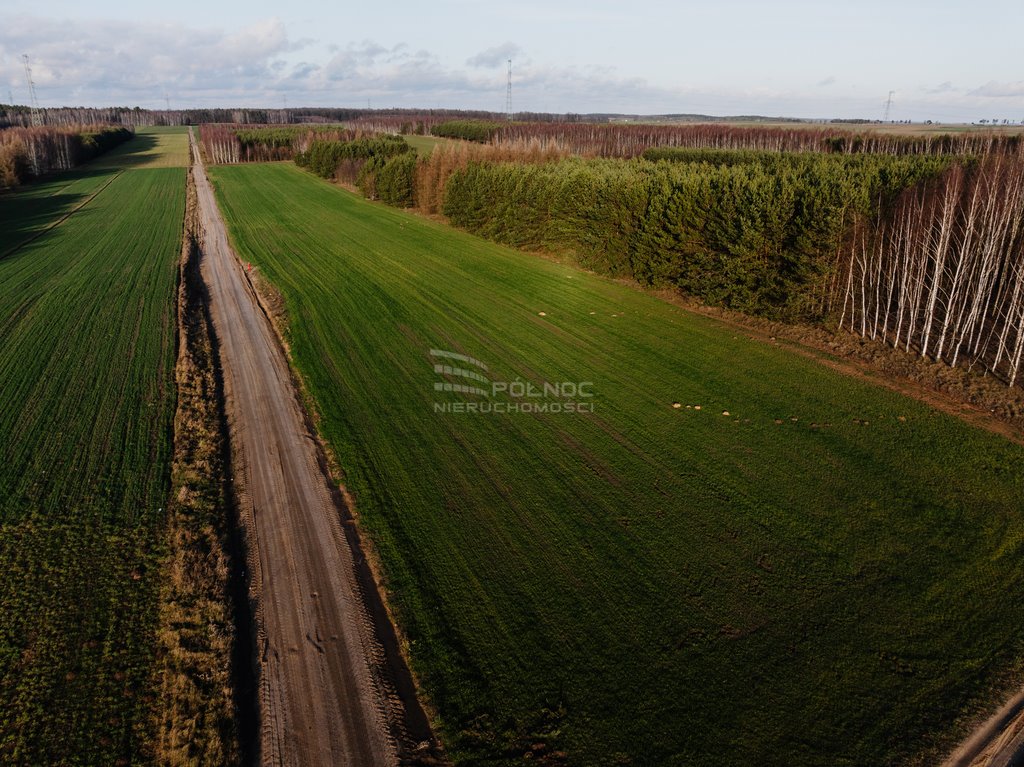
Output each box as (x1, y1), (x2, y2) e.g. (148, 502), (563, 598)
(0, 139), (185, 765)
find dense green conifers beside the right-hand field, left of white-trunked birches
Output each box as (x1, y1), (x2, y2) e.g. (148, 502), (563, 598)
(442, 151), (950, 321)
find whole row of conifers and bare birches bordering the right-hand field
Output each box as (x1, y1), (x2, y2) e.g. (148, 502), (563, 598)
(292, 138), (1024, 384)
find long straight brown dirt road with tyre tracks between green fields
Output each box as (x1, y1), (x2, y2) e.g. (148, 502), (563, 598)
(193, 134), (398, 767)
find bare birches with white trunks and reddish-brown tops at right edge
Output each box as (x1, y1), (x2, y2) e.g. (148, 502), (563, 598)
(831, 155), (1024, 386)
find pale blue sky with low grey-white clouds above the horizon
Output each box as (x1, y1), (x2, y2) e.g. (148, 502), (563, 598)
(0, 0), (1024, 123)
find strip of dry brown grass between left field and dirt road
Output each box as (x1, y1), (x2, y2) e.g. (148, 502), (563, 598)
(154, 168), (240, 767)
